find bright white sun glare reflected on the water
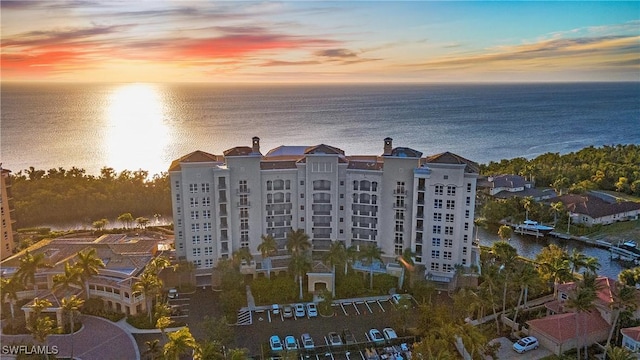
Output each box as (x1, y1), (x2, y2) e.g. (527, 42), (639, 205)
(103, 83), (171, 174)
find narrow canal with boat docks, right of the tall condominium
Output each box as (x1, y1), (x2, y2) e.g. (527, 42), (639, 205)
(478, 228), (625, 279)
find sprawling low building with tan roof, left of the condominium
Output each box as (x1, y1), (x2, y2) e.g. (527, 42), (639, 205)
(0, 234), (162, 319)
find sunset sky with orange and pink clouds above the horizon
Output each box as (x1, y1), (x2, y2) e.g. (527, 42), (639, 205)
(1, 0), (640, 83)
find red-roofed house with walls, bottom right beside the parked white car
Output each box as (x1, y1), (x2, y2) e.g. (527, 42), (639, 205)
(527, 277), (640, 355)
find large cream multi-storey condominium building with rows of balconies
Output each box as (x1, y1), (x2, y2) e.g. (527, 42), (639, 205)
(169, 137), (478, 282)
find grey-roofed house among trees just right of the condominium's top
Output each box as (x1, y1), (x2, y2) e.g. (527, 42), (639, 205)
(478, 174), (556, 201)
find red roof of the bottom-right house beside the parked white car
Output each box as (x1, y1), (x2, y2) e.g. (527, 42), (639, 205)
(527, 310), (610, 343)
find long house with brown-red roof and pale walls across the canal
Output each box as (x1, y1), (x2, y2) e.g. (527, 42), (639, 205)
(551, 193), (640, 226)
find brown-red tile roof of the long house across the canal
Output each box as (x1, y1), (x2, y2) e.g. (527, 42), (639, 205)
(552, 193), (640, 219)
